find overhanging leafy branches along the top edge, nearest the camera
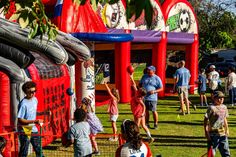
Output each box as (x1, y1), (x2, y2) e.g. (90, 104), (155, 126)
(0, 0), (153, 39)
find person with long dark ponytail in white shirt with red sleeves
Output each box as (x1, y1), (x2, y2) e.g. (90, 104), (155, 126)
(115, 119), (152, 157)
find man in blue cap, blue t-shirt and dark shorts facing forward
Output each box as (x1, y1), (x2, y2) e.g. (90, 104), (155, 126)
(140, 66), (163, 129)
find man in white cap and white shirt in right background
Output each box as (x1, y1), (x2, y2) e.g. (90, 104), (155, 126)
(207, 64), (220, 100)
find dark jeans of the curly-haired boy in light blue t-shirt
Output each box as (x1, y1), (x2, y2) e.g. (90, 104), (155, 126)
(19, 132), (41, 157)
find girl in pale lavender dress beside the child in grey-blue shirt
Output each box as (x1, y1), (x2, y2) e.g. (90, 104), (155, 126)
(81, 97), (103, 155)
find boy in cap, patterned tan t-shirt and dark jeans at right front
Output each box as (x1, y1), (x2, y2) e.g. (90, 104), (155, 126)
(204, 91), (230, 157)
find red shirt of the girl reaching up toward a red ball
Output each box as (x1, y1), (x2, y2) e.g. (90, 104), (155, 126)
(130, 97), (144, 118)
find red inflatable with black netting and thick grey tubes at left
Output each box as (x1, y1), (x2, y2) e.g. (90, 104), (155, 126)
(0, 18), (91, 156)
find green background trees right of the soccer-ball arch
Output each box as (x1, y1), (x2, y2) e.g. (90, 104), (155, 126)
(191, 0), (236, 53)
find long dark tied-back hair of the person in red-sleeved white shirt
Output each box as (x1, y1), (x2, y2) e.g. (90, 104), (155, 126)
(121, 120), (142, 150)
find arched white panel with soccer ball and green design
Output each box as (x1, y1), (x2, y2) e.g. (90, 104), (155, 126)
(166, 2), (198, 34)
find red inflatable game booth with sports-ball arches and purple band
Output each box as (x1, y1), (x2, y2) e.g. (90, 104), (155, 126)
(48, 0), (198, 102)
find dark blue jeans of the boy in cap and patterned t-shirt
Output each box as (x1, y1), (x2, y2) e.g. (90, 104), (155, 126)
(207, 135), (230, 157)
